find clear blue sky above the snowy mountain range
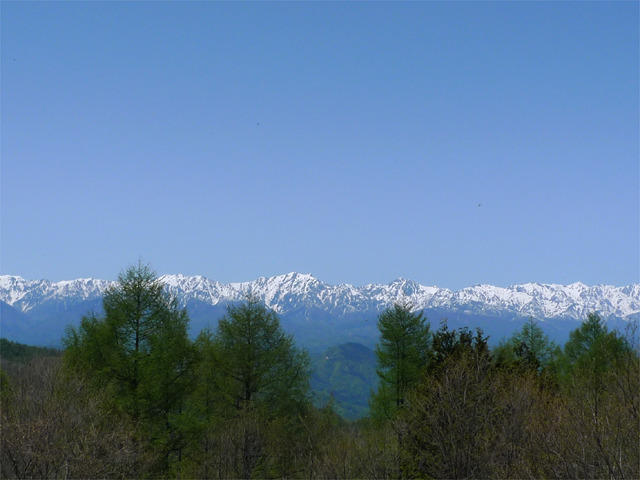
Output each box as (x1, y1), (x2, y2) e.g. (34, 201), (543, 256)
(0, 2), (640, 288)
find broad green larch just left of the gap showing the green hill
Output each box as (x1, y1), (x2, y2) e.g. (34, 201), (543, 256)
(178, 299), (310, 478)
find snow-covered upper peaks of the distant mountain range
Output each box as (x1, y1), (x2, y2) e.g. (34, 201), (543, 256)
(0, 272), (640, 320)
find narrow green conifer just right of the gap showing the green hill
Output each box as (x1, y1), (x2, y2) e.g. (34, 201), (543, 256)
(371, 304), (430, 418)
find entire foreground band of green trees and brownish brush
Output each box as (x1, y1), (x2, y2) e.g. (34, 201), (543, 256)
(0, 264), (640, 479)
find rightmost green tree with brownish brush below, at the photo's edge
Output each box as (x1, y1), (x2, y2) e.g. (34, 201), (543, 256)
(537, 313), (640, 478)
